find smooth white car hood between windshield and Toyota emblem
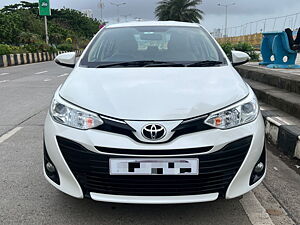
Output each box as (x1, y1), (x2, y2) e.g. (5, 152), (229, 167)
(59, 66), (249, 120)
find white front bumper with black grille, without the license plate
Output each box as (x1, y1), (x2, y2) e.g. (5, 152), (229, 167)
(44, 112), (264, 204)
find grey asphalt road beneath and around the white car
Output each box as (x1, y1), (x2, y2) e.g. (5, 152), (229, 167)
(0, 62), (300, 225)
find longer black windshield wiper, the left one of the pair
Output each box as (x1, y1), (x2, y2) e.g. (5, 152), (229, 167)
(97, 60), (185, 68)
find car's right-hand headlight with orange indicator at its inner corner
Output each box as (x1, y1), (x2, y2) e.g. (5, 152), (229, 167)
(205, 92), (259, 129)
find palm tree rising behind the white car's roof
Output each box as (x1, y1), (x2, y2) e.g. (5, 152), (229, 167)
(155, 0), (204, 23)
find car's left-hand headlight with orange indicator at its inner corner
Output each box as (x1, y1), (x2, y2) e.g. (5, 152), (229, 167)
(50, 94), (103, 130)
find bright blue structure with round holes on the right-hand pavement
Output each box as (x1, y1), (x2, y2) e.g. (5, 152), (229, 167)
(260, 32), (300, 69)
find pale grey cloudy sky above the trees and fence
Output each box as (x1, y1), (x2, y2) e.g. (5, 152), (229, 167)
(0, 0), (300, 33)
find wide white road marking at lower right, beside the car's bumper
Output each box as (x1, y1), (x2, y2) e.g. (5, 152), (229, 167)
(240, 191), (274, 225)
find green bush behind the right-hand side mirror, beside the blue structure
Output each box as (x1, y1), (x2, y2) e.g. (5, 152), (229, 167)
(221, 42), (259, 61)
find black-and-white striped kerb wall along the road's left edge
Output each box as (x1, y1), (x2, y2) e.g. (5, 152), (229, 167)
(0, 50), (83, 67)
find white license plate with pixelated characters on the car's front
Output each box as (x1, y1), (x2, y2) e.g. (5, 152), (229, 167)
(109, 158), (199, 175)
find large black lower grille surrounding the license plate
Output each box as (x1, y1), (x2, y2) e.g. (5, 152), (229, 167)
(57, 136), (252, 197)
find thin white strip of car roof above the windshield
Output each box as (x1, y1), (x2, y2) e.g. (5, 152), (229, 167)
(106, 21), (201, 28)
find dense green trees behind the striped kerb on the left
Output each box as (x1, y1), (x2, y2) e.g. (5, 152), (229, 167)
(0, 1), (102, 52)
